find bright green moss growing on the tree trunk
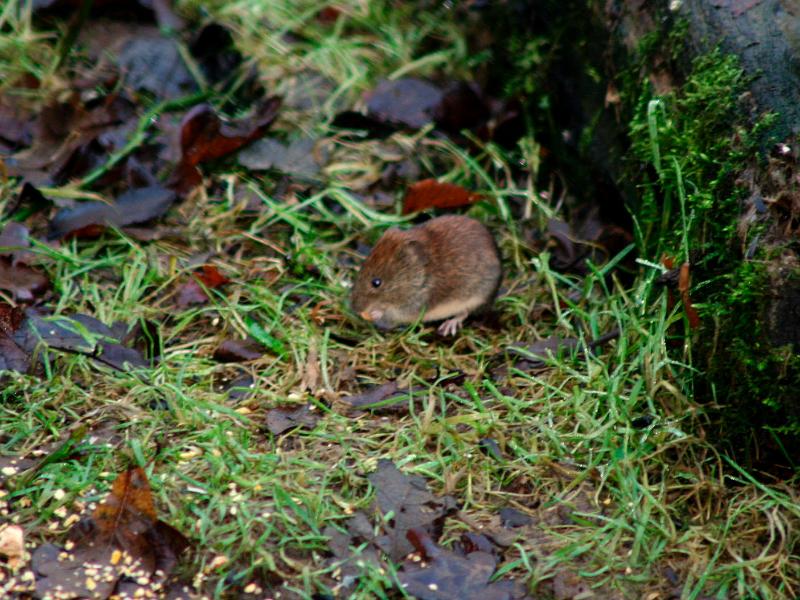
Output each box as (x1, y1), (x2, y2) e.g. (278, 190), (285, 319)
(630, 49), (800, 446)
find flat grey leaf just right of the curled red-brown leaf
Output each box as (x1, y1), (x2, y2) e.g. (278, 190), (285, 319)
(239, 138), (327, 180)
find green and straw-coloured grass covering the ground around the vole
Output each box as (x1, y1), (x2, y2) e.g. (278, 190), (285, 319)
(0, 0), (800, 598)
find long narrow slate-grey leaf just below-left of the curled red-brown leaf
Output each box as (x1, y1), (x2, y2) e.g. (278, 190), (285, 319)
(48, 185), (176, 239)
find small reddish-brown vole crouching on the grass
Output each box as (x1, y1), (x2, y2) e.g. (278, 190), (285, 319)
(351, 215), (502, 335)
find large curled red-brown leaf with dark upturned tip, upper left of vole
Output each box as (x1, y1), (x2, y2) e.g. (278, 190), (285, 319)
(171, 96), (281, 192)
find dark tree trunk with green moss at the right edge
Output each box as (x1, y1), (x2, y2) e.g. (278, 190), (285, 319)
(506, 0), (800, 464)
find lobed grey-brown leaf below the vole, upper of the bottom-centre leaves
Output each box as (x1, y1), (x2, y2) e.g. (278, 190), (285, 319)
(367, 459), (456, 561)
